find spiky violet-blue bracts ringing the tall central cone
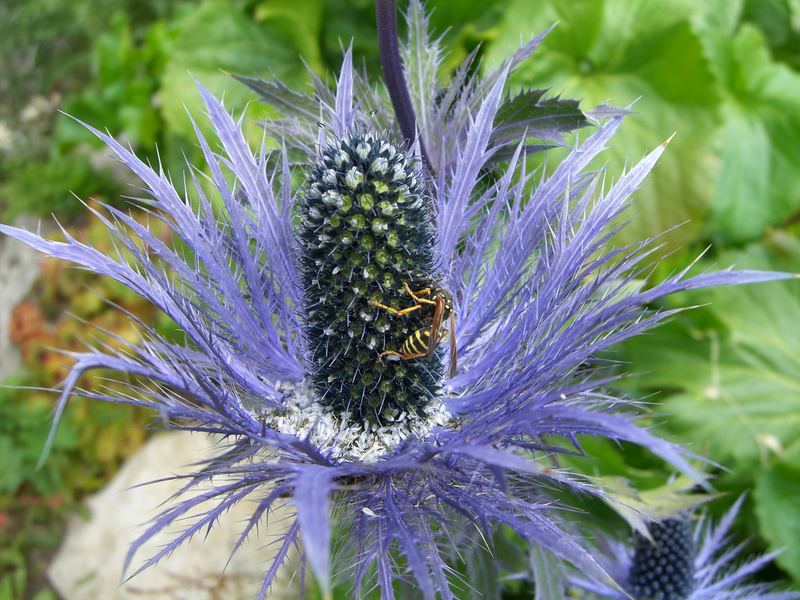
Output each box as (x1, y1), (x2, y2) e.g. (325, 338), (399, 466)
(0, 2), (783, 600)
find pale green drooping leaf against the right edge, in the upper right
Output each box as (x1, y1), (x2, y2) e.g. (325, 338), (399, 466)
(705, 25), (800, 241)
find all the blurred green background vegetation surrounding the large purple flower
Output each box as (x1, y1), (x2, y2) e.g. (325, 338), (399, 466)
(0, 0), (800, 600)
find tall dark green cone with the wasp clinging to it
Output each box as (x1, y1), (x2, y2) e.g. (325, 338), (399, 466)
(298, 134), (442, 422)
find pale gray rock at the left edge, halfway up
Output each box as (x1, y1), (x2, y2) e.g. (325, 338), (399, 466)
(0, 218), (40, 383)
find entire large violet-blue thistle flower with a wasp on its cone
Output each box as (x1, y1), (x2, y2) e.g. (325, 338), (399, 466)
(0, 2), (783, 599)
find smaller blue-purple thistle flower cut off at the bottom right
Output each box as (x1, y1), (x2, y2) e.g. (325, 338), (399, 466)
(571, 496), (800, 600)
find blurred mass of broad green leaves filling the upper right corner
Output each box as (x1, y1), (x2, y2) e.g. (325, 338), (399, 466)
(488, 0), (800, 246)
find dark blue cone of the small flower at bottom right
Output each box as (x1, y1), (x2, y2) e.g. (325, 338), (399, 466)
(629, 518), (694, 600)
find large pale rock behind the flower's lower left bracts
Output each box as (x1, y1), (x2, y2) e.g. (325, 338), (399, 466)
(48, 432), (299, 600)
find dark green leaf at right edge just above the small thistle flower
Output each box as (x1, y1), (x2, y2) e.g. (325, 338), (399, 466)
(753, 444), (800, 581)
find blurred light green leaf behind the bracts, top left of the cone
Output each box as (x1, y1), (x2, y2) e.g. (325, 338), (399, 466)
(159, 0), (307, 137)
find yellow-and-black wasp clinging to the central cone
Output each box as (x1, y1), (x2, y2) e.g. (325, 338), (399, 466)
(369, 282), (457, 377)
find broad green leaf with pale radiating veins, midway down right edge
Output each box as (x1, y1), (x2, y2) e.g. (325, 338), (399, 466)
(618, 244), (800, 464)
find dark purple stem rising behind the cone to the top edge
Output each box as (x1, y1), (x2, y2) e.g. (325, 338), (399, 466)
(375, 0), (433, 173)
